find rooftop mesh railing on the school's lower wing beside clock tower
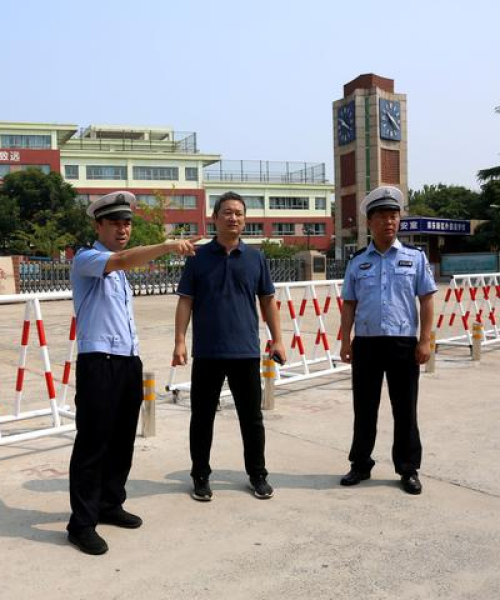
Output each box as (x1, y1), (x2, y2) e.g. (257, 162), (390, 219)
(203, 160), (327, 183)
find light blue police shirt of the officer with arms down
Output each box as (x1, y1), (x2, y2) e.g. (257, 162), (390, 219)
(342, 239), (437, 337)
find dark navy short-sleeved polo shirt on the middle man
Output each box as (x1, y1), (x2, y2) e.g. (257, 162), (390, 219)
(177, 238), (274, 358)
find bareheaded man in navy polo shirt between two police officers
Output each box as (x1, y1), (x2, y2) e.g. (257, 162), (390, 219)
(173, 192), (286, 501)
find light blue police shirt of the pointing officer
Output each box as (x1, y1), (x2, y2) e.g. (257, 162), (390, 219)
(71, 241), (139, 356)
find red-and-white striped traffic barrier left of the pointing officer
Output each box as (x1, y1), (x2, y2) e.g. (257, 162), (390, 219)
(0, 292), (76, 445)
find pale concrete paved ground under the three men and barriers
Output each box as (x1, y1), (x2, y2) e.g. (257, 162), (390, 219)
(0, 290), (500, 600)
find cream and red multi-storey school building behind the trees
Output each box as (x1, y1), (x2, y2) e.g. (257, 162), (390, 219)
(0, 122), (334, 251)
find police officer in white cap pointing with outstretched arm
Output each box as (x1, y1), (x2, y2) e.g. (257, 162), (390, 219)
(67, 192), (195, 554)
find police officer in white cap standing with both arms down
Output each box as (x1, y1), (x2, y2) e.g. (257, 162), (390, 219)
(340, 186), (437, 494)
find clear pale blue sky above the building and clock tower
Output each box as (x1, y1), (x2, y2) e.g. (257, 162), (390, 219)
(0, 0), (500, 189)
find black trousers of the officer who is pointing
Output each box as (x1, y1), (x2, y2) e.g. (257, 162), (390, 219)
(67, 352), (143, 532)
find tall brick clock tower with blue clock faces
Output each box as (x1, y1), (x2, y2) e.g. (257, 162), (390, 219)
(333, 73), (408, 258)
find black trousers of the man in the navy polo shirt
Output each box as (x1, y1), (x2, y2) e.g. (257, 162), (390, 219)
(189, 358), (267, 477)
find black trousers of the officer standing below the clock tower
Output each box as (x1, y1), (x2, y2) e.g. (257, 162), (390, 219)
(349, 336), (422, 475)
